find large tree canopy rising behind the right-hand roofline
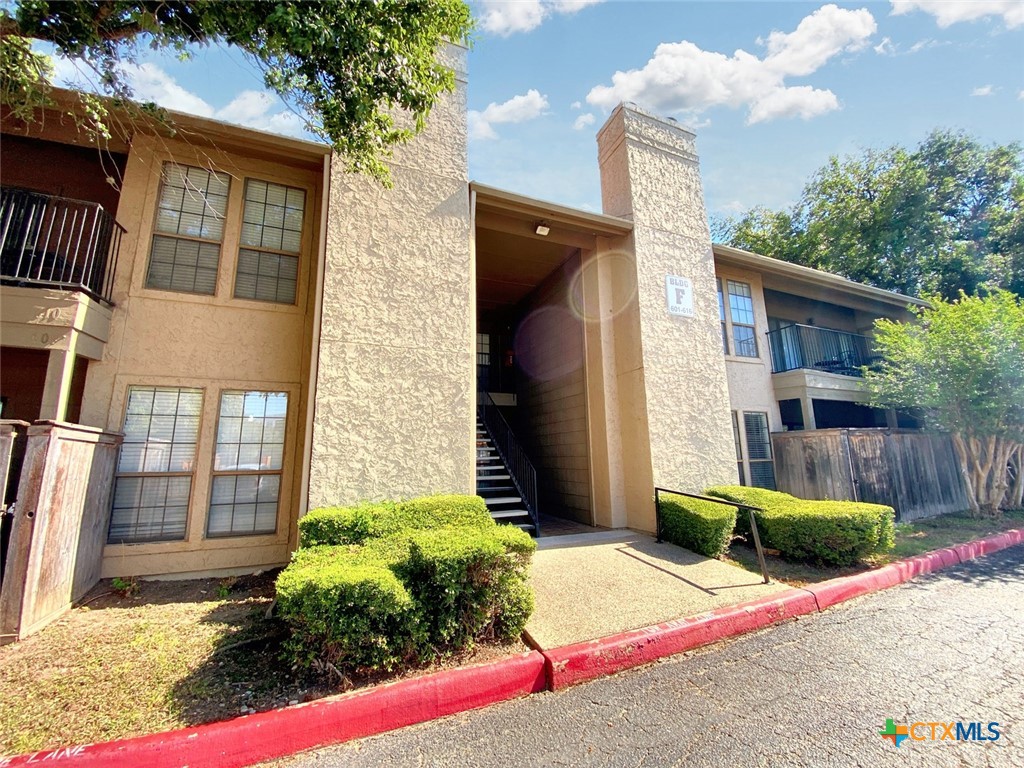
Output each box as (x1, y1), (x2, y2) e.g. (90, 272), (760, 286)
(717, 131), (1024, 299)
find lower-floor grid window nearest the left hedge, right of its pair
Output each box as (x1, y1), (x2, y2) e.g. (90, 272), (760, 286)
(206, 392), (288, 537)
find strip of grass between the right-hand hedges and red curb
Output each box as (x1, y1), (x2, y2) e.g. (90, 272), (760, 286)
(723, 510), (1024, 587)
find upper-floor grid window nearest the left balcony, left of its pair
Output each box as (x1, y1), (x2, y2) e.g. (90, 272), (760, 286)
(145, 163), (229, 296)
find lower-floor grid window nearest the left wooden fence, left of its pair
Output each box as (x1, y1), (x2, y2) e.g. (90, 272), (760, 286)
(108, 387), (203, 544)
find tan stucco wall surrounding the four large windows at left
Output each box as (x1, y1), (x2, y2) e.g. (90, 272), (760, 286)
(75, 135), (323, 577)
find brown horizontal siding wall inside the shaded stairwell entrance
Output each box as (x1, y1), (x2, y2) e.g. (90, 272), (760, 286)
(515, 255), (592, 523)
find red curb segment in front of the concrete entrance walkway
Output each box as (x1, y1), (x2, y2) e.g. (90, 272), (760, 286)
(542, 589), (817, 690)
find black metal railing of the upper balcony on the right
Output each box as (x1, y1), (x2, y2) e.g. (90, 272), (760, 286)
(768, 324), (879, 376)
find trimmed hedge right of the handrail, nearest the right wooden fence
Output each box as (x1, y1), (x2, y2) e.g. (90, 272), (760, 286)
(706, 485), (896, 565)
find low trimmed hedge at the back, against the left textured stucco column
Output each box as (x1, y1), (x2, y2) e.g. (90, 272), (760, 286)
(299, 496), (495, 547)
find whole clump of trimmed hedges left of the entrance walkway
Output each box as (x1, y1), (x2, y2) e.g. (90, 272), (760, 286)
(278, 496), (537, 670)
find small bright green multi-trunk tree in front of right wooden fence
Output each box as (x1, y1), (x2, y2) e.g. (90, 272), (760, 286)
(865, 291), (1024, 514)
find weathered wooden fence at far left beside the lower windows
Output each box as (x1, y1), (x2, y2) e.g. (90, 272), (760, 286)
(0, 421), (122, 644)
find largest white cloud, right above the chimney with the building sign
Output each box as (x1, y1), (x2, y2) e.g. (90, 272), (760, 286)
(587, 5), (878, 124)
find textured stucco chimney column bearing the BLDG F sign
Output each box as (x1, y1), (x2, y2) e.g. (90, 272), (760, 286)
(598, 105), (735, 530)
